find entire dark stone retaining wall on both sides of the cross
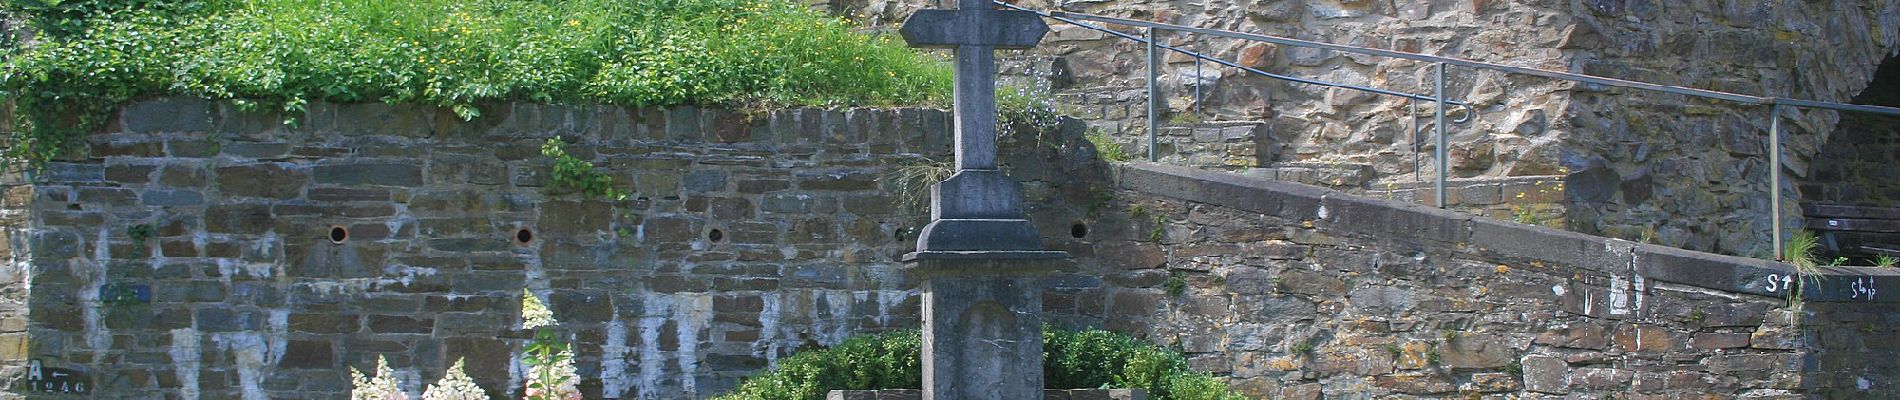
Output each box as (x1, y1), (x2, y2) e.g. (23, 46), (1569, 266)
(0, 99), (1900, 398)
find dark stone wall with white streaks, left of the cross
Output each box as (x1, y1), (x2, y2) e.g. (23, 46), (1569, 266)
(0, 99), (950, 398)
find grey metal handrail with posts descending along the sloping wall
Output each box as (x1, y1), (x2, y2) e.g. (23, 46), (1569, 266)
(1033, 8), (1900, 260)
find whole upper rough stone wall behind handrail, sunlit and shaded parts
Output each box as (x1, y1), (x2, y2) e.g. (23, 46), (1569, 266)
(863, 0), (1900, 254)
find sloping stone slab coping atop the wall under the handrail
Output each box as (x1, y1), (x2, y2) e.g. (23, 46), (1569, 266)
(1115, 163), (1900, 303)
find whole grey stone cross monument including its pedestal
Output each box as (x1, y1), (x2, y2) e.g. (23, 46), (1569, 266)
(899, 0), (1068, 400)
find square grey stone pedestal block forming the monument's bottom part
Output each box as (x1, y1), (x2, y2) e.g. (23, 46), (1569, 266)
(904, 250), (1070, 400)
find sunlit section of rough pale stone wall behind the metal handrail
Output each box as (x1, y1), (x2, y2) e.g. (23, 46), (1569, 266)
(863, 0), (1575, 190)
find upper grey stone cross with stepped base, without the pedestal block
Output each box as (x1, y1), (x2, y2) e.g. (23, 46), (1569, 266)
(899, 0), (1049, 252)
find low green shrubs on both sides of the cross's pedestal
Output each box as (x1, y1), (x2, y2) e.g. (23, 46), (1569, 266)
(720, 326), (1243, 400)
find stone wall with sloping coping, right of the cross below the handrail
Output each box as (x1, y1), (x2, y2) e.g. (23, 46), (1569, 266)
(1085, 165), (1900, 398)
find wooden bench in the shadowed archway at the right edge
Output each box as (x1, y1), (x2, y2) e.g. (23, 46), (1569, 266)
(1801, 203), (1900, 256)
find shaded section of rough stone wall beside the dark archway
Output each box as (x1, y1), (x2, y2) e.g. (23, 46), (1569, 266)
(1564, 0), (1900, 256)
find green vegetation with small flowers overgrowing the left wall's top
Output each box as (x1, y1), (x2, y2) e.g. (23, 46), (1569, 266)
(0, 0), (950, 161)
